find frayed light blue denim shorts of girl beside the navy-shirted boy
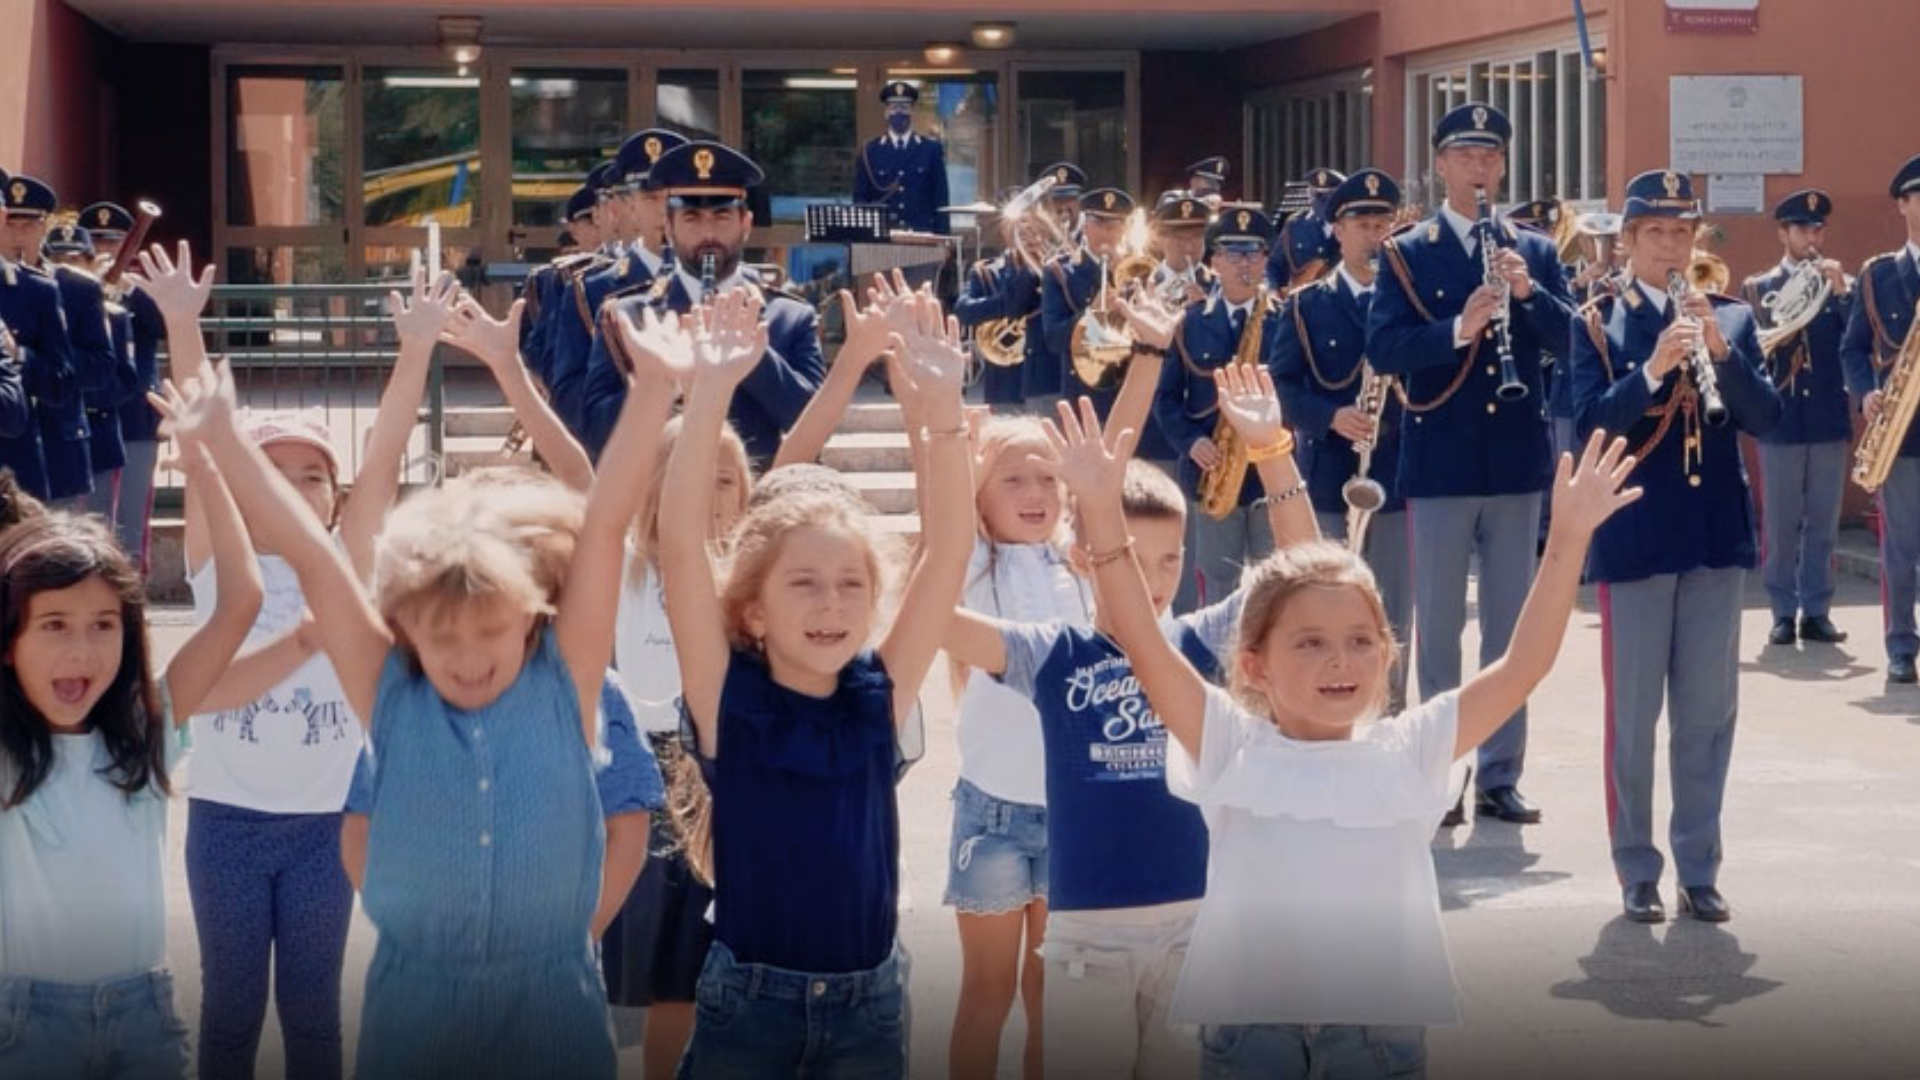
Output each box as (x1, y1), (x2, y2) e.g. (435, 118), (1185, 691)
(943, 780), (1046, 915)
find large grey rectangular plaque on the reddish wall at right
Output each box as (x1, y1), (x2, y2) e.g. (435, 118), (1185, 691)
(1667, 75), (1805, 173)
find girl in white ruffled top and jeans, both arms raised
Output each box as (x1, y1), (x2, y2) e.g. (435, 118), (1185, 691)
(1060, 401), (1640, 1078)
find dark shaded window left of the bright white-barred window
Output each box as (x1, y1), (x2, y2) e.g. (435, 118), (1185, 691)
(1246, 69), (1373, 204)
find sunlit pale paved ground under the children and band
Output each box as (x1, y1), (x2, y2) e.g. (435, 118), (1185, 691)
(145, 578), (1920, 1080)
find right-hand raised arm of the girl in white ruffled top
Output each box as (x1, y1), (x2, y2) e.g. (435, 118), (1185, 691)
(1453, 430), (1640, 757)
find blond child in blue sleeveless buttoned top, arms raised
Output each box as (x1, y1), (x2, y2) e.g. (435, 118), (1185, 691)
(187, 297), (674, 1078)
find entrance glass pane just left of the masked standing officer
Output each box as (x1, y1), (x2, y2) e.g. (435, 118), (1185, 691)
(741, 69), (858, 221)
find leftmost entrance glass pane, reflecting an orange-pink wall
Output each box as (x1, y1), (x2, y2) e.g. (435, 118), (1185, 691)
(227, 67), (346, 225)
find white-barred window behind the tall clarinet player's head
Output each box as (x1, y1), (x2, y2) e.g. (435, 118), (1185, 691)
(1407, 42), (1607, 206)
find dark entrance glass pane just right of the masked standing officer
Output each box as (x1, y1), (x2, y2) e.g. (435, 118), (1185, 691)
(1020, 71), (1127, 188)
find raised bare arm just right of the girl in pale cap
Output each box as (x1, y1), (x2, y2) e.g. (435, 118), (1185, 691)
(340, 273), (461, 582)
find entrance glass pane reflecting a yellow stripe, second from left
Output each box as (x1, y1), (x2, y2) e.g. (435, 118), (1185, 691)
(361, 67), (480, 225)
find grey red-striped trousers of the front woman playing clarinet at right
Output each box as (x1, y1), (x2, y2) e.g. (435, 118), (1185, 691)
(1599, 567), (1745, 886)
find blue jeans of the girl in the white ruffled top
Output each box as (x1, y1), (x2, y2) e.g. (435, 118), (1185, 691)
(1200, 1024), (1427, 1080)
